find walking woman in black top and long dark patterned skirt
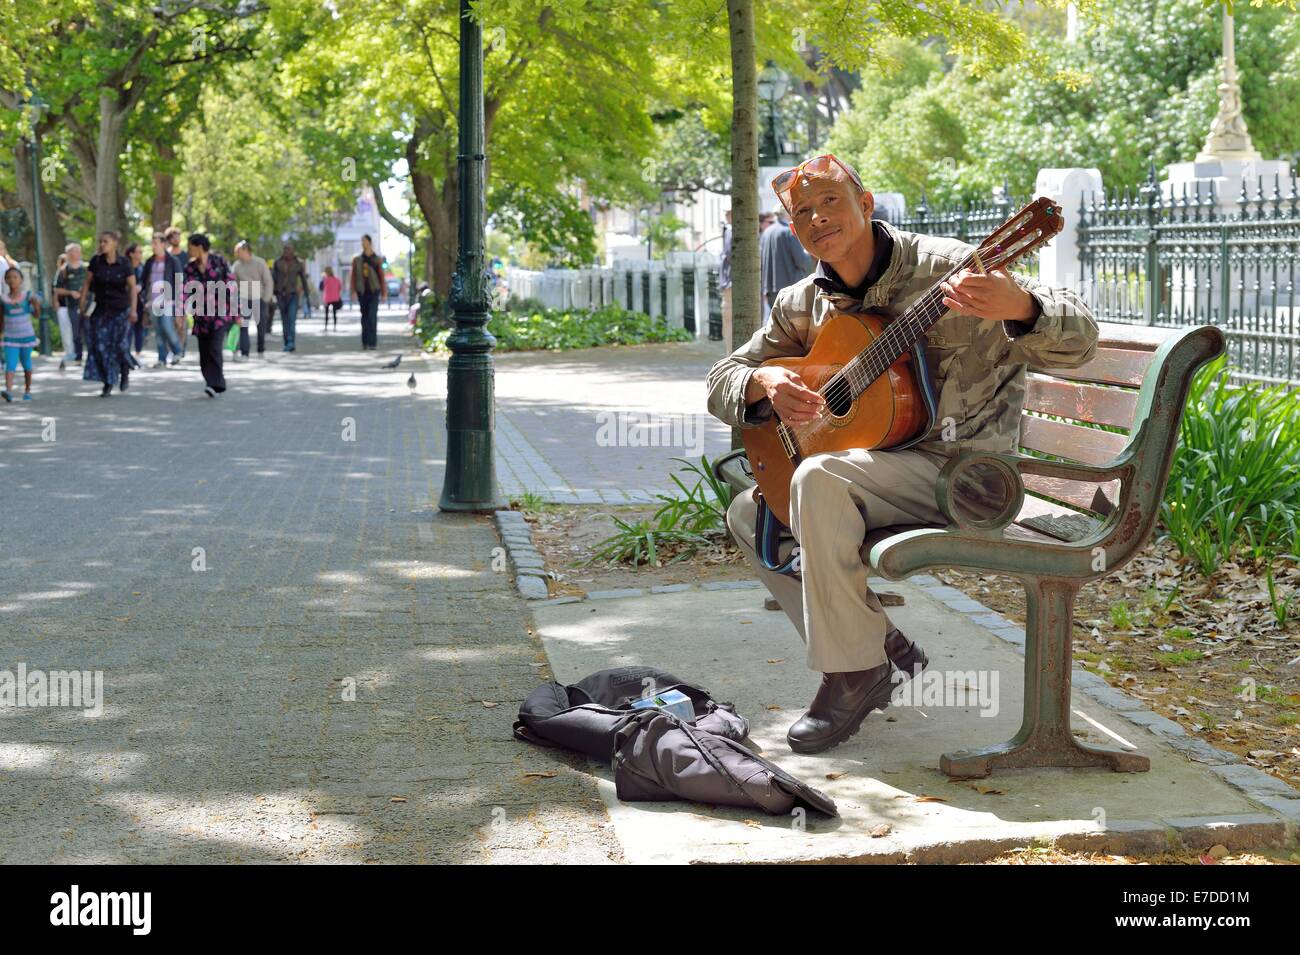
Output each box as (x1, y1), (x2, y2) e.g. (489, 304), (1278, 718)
(81, 230), (139, 398)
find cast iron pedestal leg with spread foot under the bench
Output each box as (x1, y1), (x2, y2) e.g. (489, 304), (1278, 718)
(939, 578), (1151, 778)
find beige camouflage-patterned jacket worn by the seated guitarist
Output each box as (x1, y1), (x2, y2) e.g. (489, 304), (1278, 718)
(707, 221), (1097, 455)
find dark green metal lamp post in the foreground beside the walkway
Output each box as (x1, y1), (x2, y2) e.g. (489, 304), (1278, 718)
(438, 0), (501, 511)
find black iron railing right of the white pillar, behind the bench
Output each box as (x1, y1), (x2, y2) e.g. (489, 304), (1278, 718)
(1079, 166), (1300, 386)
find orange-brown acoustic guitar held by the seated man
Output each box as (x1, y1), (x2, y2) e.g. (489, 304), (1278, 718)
(741, 197), (1062, 525)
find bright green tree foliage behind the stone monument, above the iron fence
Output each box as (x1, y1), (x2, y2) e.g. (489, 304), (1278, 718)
(828, 0), (1300, 204)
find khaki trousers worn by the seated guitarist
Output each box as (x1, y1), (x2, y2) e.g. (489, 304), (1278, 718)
(727, 450), (948, 673)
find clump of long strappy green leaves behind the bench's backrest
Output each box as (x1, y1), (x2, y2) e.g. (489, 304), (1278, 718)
(1161, 357), (1300, 576)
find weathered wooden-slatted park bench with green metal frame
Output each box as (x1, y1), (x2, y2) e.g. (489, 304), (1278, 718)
(714, 322), (1223, 777)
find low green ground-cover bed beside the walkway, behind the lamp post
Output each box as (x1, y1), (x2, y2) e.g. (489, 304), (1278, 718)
(423, 305), (692, 352)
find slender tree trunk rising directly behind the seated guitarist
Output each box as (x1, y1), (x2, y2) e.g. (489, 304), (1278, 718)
(727, 0), (762, 448)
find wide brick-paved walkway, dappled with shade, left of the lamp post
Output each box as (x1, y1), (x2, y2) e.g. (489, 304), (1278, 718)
(0, 312), (618, 863)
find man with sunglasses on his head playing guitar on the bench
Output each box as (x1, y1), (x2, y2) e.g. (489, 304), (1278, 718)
(707, 155), (1097, 752)
